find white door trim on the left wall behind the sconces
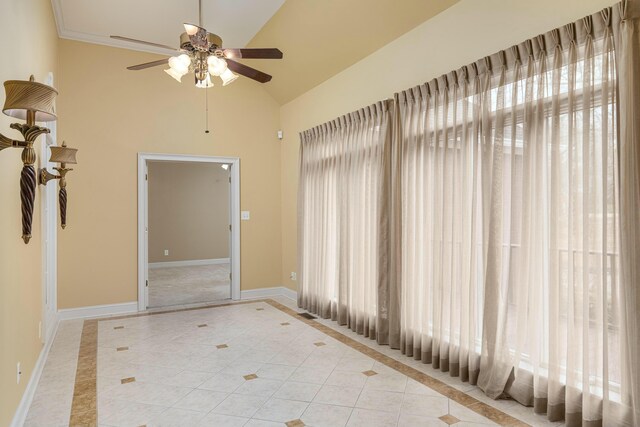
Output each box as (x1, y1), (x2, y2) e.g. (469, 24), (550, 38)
(39, 73), (58, 343)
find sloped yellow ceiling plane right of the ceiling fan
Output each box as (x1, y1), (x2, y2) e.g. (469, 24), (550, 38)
(247, 0), (458, 104)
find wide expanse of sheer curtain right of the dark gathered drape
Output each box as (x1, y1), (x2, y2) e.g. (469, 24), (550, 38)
(394, 9), (633, 425)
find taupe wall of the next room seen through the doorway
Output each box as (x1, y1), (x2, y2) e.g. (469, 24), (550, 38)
(148, 162), (230, 262)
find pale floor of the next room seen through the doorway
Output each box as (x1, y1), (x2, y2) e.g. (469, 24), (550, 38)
(149, 263), (231, 308)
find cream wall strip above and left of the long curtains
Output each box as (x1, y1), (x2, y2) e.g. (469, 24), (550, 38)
(280, 0), (615, 289)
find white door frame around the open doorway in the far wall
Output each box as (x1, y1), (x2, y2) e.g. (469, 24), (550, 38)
(138, 153), (240, 311)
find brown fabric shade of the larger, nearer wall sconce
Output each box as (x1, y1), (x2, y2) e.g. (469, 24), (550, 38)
(2, 80), (58, 122)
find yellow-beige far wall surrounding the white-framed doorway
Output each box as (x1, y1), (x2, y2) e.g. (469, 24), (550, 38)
(58, 40), (282, 308)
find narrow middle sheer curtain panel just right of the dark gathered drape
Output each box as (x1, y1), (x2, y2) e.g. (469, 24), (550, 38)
(394, 76), (483, 383)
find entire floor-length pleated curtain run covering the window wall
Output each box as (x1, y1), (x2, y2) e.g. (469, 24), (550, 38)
(298, 1), (640, 426)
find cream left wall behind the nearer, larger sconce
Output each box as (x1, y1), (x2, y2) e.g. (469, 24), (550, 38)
(0, 0), (58, 426)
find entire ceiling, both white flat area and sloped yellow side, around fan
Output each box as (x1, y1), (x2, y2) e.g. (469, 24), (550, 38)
(52, 0), (458, 104)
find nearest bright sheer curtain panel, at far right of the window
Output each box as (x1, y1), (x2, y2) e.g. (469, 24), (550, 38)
(478, 14), (625, 425)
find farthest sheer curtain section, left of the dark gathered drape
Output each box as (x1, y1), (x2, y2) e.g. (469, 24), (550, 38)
(298, 102), (390, 339)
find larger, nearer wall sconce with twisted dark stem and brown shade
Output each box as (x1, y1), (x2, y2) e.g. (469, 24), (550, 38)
(0, 76), (58, 244)
